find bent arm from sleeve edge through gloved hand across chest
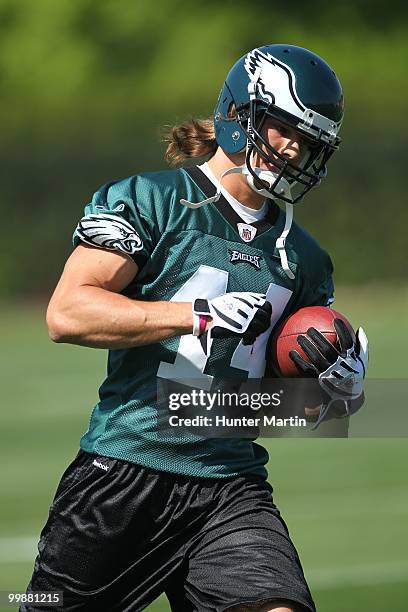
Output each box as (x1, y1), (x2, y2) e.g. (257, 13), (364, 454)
(47, 245), (271, 352)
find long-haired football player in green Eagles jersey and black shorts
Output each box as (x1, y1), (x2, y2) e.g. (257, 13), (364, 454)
(21, 44), (366, 612)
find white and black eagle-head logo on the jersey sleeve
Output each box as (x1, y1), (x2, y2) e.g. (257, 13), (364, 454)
(75, 214), (143, 255)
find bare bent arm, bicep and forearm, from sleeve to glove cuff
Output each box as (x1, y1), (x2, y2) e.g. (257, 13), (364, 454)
(47, 245), (193, 349)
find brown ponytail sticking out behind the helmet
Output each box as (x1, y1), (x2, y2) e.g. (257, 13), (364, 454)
(163, 119), (218, 166)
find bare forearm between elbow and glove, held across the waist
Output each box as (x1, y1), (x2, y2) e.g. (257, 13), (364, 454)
(47, 286), (193, 349)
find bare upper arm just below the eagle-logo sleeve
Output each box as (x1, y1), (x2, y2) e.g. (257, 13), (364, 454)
(52, 244), (138, 300)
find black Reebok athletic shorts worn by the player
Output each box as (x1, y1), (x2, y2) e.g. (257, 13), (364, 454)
(20, 451), (315, 612)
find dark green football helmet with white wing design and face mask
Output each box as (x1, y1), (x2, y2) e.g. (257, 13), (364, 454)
(214, 45), (344, 204)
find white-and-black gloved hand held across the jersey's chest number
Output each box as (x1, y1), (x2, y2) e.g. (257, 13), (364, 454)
(193, 291), (272, 355)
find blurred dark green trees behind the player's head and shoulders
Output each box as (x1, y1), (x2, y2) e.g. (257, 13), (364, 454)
(0, 0), (408, 298)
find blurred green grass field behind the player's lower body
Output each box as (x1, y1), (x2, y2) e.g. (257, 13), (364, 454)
(0, 287), (408, 612)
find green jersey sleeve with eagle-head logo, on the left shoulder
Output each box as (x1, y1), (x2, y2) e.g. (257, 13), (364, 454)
(73, 179), (157, 267)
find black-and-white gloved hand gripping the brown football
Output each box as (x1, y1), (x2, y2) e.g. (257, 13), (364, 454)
(289, 319), (368, 426)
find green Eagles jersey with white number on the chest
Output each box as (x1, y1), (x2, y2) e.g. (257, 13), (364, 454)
(74, 167), (333, 478)
